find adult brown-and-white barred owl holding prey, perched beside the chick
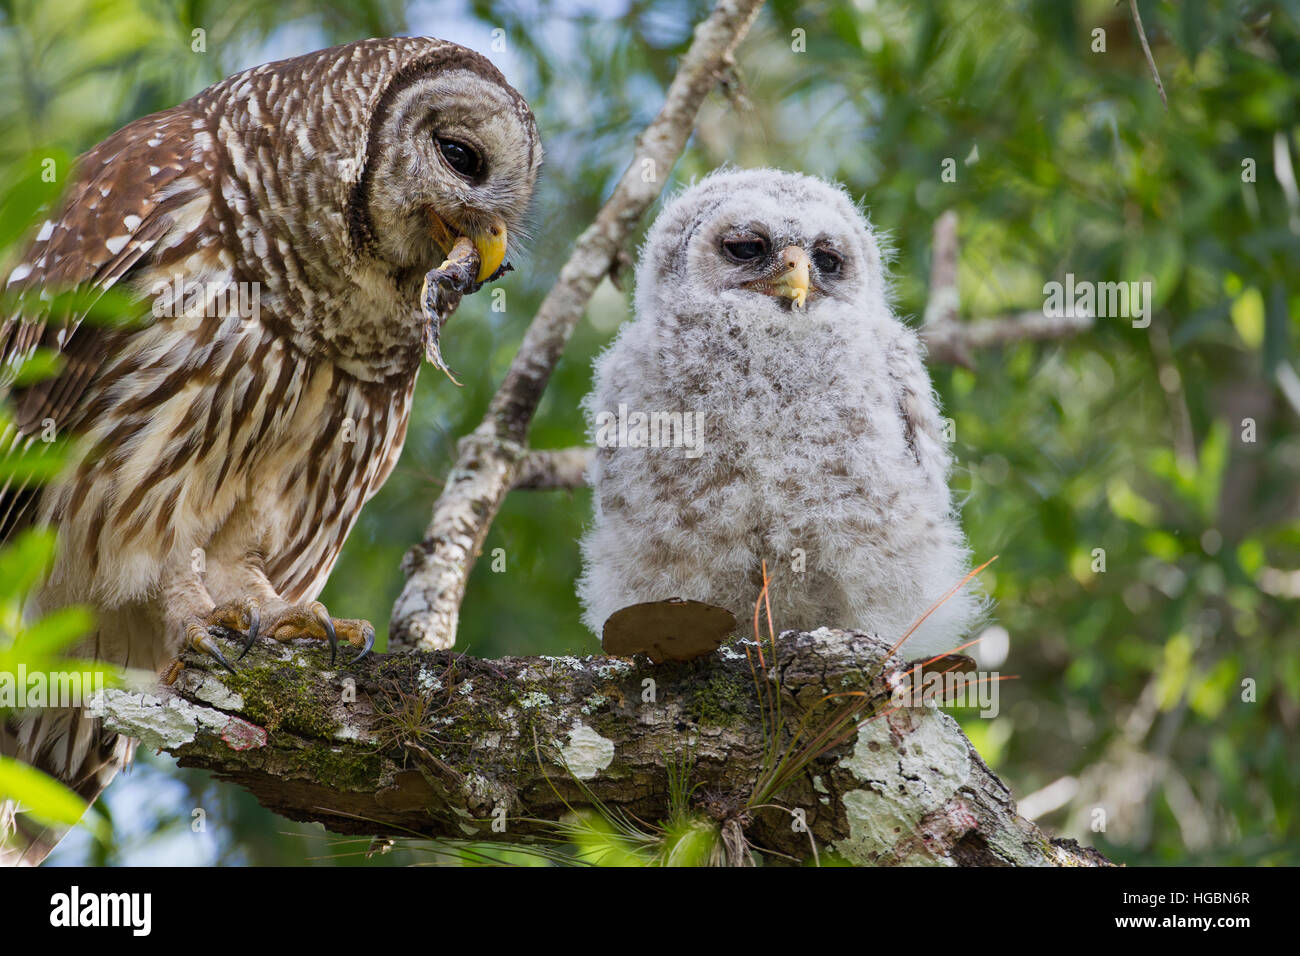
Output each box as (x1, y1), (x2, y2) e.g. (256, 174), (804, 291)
(0, 38), (542, 862)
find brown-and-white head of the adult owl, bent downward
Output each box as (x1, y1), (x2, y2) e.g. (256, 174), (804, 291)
(205, 36), (542, 286)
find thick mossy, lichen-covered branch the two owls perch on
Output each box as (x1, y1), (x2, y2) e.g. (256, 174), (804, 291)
(104, 628), (1108, 866)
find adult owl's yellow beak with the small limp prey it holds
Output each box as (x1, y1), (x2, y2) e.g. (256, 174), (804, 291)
(420, 209), (510, 385)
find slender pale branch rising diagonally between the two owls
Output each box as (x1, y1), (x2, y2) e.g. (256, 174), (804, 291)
(389, 0), (762, 650)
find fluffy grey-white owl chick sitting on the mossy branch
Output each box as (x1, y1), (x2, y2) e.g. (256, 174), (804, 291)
(579, 169), (982, 656)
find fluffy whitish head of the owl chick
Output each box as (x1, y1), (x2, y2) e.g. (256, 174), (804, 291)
(637, 169), (887, 325)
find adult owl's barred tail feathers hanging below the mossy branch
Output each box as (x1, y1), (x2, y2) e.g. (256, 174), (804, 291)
(0, 708), (135, 866)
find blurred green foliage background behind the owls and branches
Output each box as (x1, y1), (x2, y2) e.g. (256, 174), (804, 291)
(0, 0), (1300, 864)
